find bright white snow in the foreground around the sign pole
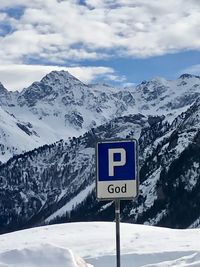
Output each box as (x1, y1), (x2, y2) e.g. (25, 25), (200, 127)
(0, 222), (200, 267)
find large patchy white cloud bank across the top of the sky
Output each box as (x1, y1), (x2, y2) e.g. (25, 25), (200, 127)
(0, 0), (200, 64)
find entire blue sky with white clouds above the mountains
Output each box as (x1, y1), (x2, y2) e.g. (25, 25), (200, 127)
(0, 0), (200, 90)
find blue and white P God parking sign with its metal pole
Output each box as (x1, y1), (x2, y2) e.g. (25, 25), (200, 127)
(96, 139), (139, 267)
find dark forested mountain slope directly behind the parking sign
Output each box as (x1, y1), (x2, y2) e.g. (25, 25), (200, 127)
(0, 99), (200, 232)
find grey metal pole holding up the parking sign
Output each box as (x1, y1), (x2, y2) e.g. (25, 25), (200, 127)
(115, 199), (121, 267)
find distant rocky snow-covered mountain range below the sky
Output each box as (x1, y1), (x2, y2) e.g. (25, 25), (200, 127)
(0, 71), (200, 162)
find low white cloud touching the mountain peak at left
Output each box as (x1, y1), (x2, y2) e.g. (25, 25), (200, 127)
(0, 65), (117, 91)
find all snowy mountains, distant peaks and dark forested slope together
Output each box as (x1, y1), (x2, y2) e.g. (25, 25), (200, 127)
(0, 72), (200, 232)
